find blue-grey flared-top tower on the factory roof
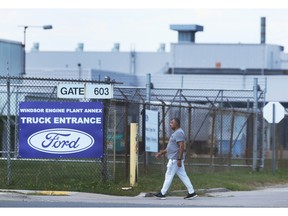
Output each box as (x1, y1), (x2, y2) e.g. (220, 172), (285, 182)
(170, 25), (204, 43)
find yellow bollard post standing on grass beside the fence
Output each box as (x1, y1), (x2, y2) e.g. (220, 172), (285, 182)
(130, 123), (138, 186)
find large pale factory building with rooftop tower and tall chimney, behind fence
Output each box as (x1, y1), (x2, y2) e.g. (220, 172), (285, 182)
(20, 17), (288, 103)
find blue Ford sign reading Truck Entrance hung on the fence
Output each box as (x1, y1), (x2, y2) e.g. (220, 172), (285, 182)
(19, 102), (104, 158)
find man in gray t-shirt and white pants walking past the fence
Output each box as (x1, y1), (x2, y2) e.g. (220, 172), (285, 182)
(154, 118), (197, 199)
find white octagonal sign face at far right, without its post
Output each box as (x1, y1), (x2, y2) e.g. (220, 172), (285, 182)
(263, 102), (285, 123)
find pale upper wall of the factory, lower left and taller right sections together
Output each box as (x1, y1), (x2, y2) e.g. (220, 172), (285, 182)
(26, 43), (283, 75)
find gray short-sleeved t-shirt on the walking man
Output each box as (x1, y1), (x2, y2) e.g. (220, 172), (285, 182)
(166, 128), (185, 160)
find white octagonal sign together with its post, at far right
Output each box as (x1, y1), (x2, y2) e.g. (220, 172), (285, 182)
(263, 102), (285, 175)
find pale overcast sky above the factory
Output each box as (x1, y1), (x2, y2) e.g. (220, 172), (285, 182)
(0, 0), (288, 52)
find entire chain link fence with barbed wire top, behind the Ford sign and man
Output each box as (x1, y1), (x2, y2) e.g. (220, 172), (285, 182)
(0, 76), (265, 190)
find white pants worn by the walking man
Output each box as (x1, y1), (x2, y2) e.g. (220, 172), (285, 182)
(161, 159), (194, 195)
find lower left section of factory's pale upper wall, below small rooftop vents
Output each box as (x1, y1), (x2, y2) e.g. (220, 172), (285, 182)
(27, 51), (170, 75)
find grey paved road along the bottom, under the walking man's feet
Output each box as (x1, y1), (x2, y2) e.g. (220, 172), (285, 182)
(0, 185), (288, 208)
